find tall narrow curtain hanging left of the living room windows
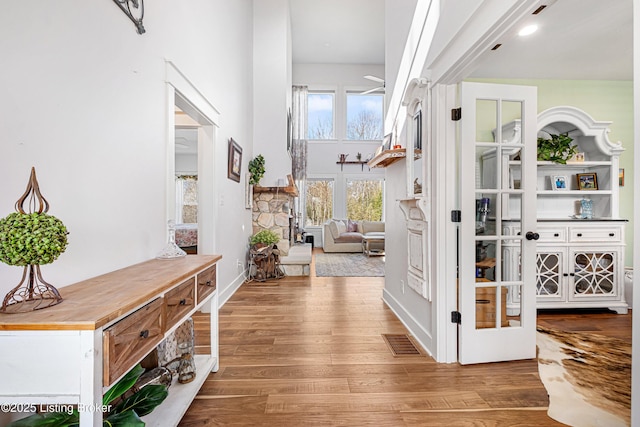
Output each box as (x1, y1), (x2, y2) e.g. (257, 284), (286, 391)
(291, 86), (309, 235)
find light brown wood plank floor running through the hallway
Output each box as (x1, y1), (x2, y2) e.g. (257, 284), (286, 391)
(180, 252), (631, 427)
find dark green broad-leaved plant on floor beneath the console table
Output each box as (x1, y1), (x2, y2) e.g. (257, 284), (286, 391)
(8, 365), (169, 427)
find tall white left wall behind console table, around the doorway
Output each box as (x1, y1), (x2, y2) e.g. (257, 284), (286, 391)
(0, 0), (253, 318)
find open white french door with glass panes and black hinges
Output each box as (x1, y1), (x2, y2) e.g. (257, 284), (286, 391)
(458, 82), (537, 364)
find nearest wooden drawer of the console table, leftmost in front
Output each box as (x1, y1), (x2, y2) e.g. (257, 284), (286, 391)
(102, 298), (164, 386)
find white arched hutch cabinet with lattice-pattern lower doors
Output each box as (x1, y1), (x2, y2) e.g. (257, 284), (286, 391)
(481, 106), (628, 315)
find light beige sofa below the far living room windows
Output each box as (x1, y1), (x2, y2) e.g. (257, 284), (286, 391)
(322, 219), (384, 252)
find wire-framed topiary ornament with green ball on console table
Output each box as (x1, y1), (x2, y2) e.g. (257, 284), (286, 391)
(0, 168), (69, 313)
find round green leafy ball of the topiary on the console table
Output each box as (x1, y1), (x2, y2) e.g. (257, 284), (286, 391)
(0, 212), (69, 266)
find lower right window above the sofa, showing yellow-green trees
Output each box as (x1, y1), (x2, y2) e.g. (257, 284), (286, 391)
(347, 179), (383, 221)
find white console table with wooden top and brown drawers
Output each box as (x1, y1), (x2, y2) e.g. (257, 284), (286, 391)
(0, 255), (222, 427)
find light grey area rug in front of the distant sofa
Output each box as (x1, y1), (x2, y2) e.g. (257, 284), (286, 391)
(315, 253), (384, 277)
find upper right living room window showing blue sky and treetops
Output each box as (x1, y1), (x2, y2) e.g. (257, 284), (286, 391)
(347, 93), (383, 141)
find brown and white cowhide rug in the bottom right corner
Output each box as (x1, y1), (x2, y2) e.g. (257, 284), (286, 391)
(536, 327), (631, 427)
